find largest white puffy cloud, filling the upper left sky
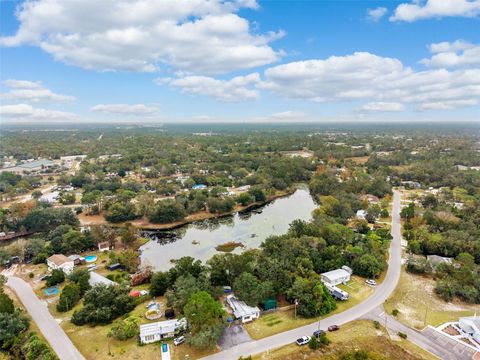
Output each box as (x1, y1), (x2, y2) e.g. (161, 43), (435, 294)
(0, 0), (284, 74)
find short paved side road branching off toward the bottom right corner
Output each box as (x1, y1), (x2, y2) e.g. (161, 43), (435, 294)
(365, 306), (475, 360)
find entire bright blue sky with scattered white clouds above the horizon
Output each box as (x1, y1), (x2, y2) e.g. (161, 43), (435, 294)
(0, 0), (480, 123)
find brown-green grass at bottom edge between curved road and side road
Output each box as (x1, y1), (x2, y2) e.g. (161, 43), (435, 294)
(253, 320), (437, 360)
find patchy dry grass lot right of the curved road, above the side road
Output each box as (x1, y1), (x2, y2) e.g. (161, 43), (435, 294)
(385, 269), (480, 329)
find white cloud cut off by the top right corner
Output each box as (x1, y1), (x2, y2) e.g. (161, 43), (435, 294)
(390, 0), (480, 22)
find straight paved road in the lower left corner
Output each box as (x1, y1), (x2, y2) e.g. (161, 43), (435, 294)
(7, 276), (85, 360)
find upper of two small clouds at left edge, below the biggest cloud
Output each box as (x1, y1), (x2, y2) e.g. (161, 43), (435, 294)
(1, 79), (75, 103)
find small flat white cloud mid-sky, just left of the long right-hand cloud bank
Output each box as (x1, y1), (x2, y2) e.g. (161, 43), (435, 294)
(155, 73), (260, 102)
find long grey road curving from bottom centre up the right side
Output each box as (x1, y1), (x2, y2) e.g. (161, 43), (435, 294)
(205, 191), (402, 360)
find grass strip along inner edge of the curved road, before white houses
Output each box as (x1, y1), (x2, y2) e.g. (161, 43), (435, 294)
(245, 276), (373, 339)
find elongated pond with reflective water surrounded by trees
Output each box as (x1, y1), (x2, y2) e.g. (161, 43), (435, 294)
(140, 187), (317, 271)
